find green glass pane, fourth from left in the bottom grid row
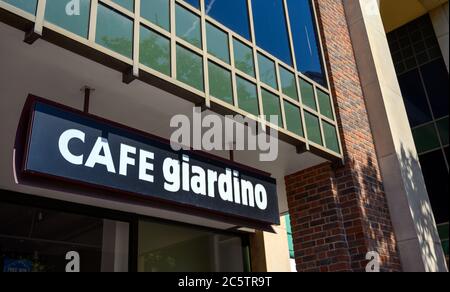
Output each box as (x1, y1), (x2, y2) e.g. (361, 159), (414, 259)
(139, 26), (170, 75)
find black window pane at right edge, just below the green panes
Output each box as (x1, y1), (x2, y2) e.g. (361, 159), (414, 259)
(420, 149), (450, 224)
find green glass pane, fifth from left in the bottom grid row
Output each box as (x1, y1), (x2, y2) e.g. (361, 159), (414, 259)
(177, 46), (204, 91)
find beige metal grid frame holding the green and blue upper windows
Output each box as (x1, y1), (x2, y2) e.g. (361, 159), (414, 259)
(0, 0), (343, 161)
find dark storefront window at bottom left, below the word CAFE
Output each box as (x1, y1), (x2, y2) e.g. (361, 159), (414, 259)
(0, 203), (129, 272)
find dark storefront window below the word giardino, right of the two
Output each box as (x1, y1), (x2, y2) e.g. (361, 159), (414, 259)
(138, 222), (245, 272)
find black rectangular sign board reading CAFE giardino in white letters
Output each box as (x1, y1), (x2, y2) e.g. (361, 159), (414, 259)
(24, 99), (279, 224)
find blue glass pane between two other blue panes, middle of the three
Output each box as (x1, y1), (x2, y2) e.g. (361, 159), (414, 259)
(252, 0), (292, 65)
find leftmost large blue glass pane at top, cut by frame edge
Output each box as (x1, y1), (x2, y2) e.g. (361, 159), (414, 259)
(205, 0), (251, 40)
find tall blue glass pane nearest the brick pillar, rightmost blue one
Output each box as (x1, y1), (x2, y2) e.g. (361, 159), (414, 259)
(287, 0), (327, 86)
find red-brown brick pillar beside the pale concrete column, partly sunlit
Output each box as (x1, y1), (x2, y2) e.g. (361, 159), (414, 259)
(286, 0), (401, 271)
